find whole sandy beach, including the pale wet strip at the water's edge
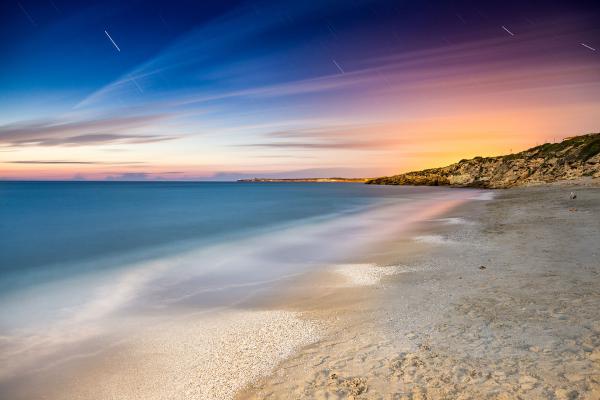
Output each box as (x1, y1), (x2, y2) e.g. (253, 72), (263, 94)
(1, 185), (600, 399)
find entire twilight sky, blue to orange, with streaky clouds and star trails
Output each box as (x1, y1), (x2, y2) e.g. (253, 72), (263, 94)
(0, 0), (600, 180)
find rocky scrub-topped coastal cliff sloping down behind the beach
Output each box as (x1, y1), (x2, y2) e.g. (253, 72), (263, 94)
(366, 133), (600, 189)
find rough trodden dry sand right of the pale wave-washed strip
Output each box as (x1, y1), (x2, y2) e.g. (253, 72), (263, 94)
(238, 185), (600, 399)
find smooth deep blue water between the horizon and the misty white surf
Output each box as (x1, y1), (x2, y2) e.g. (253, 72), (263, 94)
(0, 182), (432, 293)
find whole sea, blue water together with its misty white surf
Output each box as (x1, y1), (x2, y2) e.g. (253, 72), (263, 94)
(0, 182), (476, 384)
